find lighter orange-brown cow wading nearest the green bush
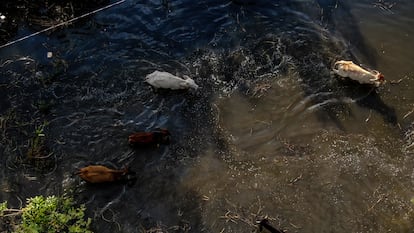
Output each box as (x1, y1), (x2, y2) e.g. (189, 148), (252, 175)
(76, 165), (128, 184)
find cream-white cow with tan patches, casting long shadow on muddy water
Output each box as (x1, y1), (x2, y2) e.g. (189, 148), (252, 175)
(333, 60), (385, 87)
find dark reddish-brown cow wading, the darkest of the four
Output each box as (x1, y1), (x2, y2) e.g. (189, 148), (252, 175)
(128, 129), (171, 146)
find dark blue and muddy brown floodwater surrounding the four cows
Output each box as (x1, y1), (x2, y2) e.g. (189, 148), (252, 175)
(0, 0), (414, 233)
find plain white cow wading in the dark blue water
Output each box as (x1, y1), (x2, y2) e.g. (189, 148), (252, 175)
(145, 71), (198, 90)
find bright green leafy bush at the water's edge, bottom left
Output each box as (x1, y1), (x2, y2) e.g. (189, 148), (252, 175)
(0, 196), (92, 233)
